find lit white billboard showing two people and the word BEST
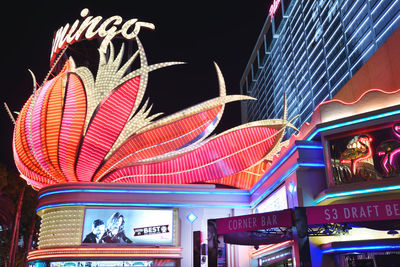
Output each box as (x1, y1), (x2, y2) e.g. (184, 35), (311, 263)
(82, 208), (174, 245)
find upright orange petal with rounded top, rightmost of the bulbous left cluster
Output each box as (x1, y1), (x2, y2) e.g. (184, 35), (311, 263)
(59, 73), (86, 181)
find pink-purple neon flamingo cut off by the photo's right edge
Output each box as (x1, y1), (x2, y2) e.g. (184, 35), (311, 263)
(376, 123), (400, 176)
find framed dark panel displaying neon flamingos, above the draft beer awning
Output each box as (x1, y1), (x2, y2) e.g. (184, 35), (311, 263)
(327, 122), (400, 184)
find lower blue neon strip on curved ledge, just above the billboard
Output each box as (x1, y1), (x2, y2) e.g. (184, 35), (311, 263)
(36, 202), (250, 212)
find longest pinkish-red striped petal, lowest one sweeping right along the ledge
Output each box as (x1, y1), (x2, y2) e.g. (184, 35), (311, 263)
(104, 126), (278, 187)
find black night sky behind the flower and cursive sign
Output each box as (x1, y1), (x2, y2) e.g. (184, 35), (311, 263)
(0, 0), (270, 171)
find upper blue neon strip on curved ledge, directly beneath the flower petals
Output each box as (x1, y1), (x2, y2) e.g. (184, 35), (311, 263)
(38, 189), (250, 199)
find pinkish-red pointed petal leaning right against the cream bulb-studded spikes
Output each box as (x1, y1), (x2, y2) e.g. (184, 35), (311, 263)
(76, 76), (140, 182)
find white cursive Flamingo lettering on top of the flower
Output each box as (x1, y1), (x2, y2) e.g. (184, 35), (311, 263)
(50, 8), (155, 64)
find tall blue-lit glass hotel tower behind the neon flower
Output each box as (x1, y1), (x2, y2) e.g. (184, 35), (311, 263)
(240, 0), (400, 136)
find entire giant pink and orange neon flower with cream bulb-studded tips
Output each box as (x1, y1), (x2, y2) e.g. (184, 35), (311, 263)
(13, 38), (294, 192)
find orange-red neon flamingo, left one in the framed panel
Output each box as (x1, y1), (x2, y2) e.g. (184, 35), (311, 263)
(340, 134), (372, 175)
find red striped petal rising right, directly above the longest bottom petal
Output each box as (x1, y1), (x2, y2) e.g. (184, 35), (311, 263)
(94, 105), (222, 181)
